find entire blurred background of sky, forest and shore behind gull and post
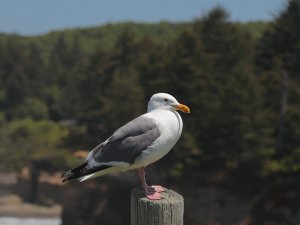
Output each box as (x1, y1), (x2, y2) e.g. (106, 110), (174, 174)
(0, 0), (300, 225)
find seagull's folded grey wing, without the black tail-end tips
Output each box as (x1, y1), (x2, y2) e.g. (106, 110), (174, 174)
(91, 116), (160, 165)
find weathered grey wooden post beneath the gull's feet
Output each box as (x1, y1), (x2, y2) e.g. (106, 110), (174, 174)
(131, 188), (184, 225)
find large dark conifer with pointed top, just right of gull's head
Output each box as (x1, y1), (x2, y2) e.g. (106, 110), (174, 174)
(158, 8), (267, 178)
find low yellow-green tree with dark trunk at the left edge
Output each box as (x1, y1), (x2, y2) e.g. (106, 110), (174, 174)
(0, 119), (72, 202)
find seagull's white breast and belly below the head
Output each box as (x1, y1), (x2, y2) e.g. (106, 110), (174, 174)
(134, 109), (182, 167)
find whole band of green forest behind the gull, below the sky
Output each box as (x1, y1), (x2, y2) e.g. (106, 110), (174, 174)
(0, 0), (300, 202)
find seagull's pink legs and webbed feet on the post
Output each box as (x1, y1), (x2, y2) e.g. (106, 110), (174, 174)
(139, 167), (164, 200)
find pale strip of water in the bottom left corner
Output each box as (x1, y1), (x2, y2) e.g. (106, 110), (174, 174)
(0, 217), (61, 225)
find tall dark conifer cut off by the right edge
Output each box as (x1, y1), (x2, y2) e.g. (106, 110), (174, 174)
(253, 0), (300, 224)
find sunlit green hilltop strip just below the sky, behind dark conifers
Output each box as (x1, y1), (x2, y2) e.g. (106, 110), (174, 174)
(0, 22), (268, 61)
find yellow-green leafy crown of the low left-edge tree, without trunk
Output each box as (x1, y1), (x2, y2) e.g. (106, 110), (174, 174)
(0, 119), (69, 170)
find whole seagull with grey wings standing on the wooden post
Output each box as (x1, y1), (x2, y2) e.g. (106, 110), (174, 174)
(61, 93), (190, 200)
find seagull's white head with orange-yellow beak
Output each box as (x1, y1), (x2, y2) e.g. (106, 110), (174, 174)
(147, 93), (190, 113)
